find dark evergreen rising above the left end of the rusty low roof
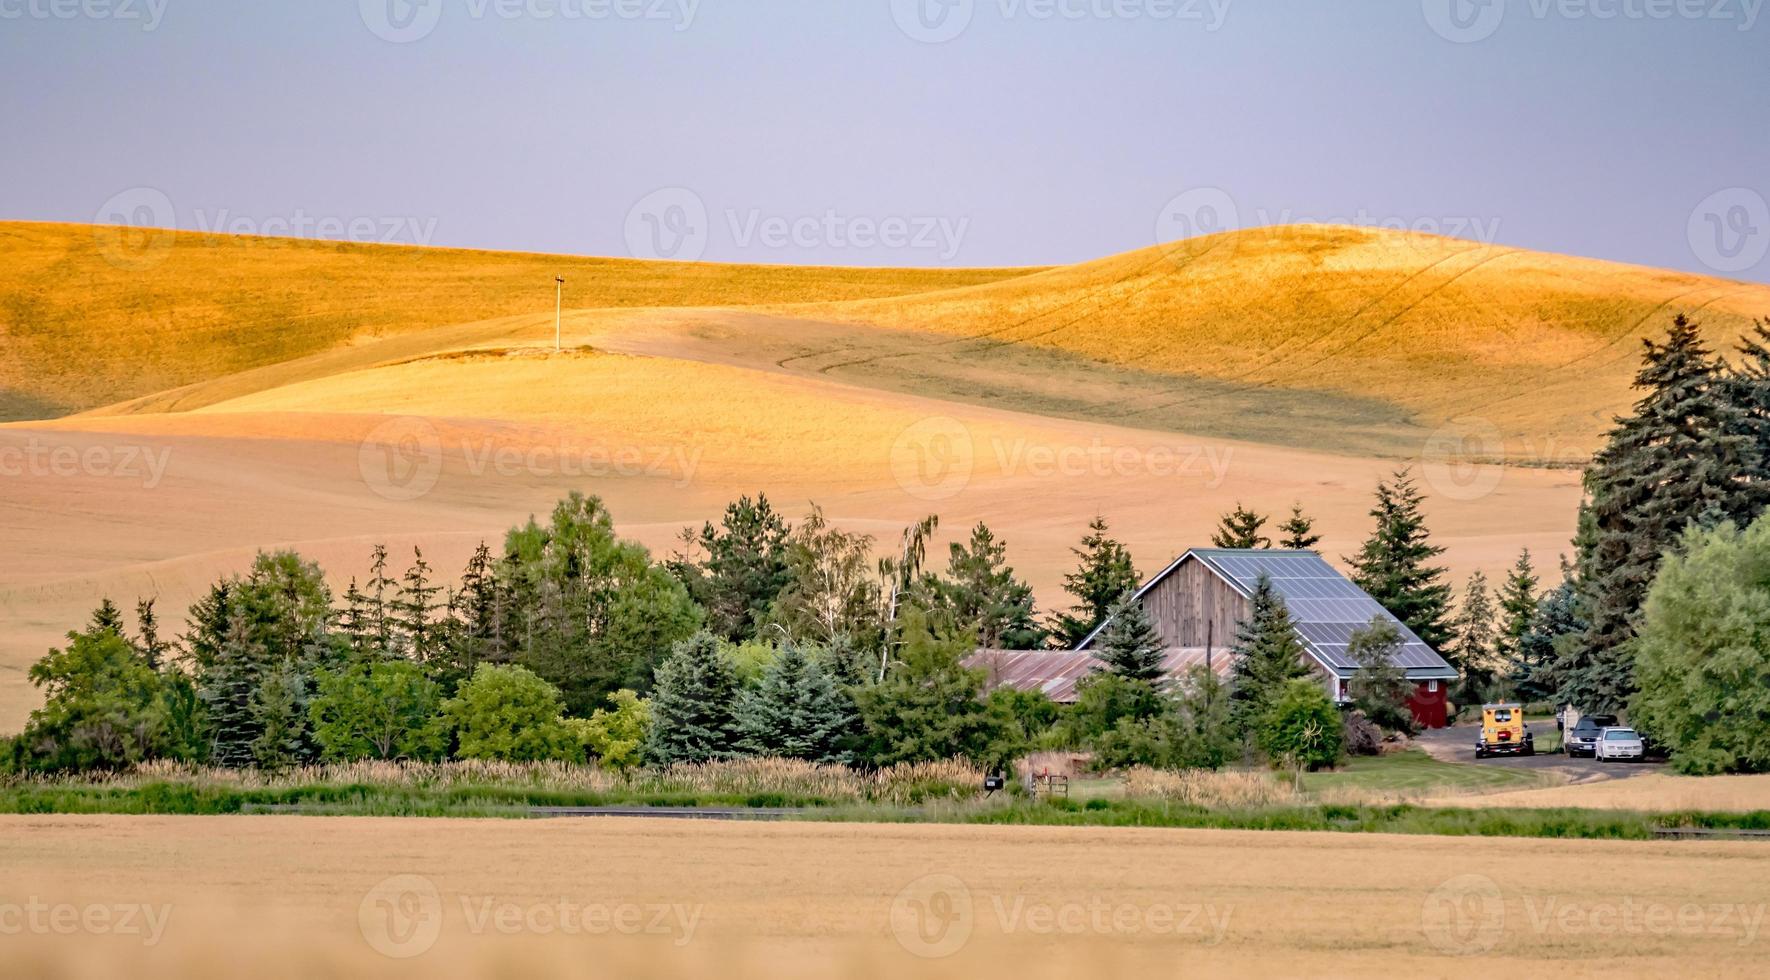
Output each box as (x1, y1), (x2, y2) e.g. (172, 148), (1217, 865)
(919, 522), (1044, 649)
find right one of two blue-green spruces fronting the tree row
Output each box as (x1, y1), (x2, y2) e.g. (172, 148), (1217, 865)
(736, 644), (857, 764)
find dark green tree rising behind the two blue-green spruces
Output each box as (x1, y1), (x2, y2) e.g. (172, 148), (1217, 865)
(671, 495), (793, 642)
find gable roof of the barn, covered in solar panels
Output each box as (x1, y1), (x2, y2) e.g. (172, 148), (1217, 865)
(1076, 548), (1457, 681)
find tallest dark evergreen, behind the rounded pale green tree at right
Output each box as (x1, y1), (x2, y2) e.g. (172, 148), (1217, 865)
(1556, 315), (1761, 711)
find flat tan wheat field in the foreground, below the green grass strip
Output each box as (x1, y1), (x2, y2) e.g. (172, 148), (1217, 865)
(0, 817), (1770, 980)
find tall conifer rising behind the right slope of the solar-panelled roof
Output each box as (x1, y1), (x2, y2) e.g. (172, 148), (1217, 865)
(1347, 469), (1453, 649)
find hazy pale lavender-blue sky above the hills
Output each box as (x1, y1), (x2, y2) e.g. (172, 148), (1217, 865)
(0, 0), (1770, 281)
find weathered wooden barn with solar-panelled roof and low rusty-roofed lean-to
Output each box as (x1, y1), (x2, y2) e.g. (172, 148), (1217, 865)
(972, 548), (1457, 727)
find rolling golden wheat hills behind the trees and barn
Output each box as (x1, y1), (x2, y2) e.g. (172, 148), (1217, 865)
(13, 223), (1770, 731)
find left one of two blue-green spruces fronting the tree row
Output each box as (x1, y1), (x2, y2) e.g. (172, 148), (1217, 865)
(646, 632), (740, 766)
